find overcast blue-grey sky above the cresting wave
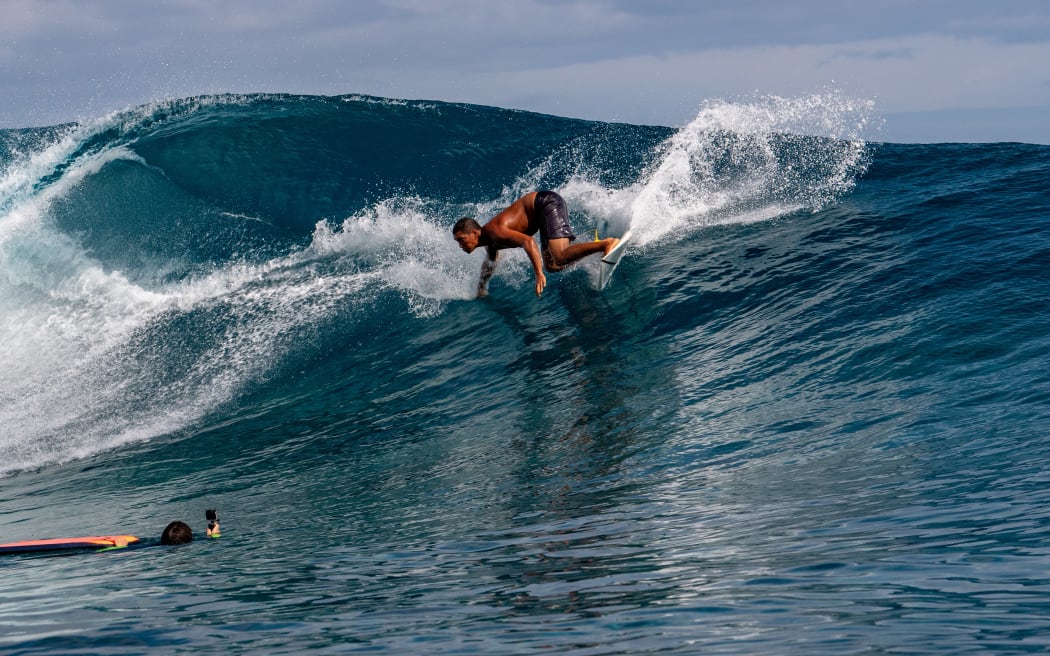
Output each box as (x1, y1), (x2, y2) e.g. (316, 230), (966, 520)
(0, 0), (1050, 144)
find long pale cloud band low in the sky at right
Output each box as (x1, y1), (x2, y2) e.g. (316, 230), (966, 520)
(405, 30), (1050, 124)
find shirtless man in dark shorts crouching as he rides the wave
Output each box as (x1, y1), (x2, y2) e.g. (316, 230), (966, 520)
(453, 191), (620, 298)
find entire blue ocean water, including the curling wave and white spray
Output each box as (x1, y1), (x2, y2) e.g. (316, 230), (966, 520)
(0, 92), (1050, 655)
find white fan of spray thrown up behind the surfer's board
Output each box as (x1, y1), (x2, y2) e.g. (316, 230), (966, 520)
(561, 93), (874, 248)
